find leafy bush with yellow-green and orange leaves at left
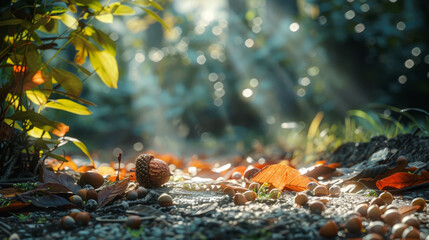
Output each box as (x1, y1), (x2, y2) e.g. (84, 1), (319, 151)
(0, 0), (162, 178)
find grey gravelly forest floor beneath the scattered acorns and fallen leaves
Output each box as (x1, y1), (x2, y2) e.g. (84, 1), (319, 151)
(0, 136), (429, 240)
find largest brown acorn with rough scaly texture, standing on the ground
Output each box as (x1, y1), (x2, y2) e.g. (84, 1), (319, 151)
(136, 154), (171, 188)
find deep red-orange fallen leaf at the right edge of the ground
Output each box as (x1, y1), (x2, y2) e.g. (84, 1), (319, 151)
(376, 171), (429, 190)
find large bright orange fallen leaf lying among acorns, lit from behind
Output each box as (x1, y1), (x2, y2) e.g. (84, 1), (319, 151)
(252, 164), (317, 192)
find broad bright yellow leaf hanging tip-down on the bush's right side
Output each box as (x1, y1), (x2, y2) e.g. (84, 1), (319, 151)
(89, 50), (119, 88)
